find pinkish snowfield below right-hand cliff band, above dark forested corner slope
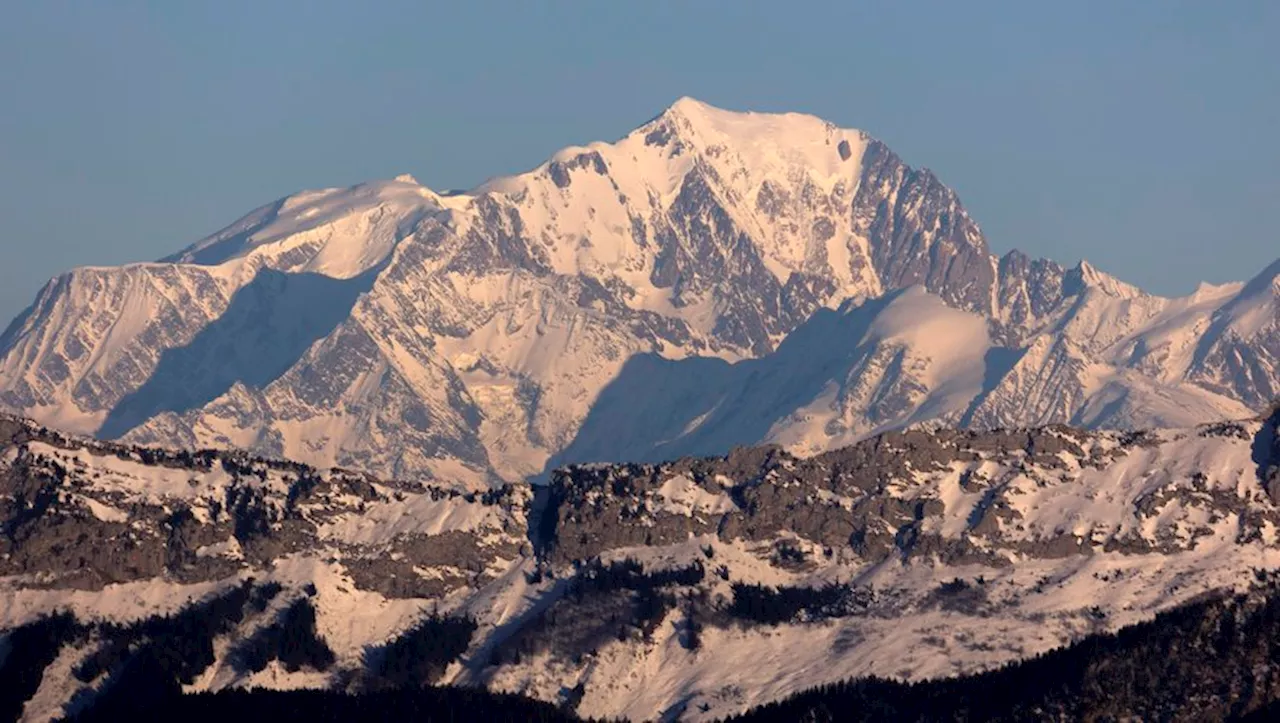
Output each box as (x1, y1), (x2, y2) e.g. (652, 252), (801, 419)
(490, 524), (1280, 720)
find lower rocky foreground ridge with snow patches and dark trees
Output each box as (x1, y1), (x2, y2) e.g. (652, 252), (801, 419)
(0, 411), (1280, 720)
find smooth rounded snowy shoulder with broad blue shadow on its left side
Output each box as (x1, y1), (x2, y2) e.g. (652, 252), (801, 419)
(556, 287), (991, 462)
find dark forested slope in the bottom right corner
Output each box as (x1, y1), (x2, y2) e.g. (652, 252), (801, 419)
(728, 576), (1280, 723)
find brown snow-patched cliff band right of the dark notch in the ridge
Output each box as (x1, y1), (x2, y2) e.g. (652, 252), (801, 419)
(544, 418), (1280, 567)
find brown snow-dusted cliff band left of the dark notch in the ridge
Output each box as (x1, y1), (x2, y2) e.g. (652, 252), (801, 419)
(0, 418), (526, 598)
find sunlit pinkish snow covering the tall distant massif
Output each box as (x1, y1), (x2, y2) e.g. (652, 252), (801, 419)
(0, 97), (1264, 488)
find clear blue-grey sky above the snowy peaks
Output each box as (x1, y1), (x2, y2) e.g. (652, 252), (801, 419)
(0, 0), (1280, 321)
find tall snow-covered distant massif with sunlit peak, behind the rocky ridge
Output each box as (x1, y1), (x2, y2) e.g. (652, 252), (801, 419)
(0, 99), (1280, 489)
